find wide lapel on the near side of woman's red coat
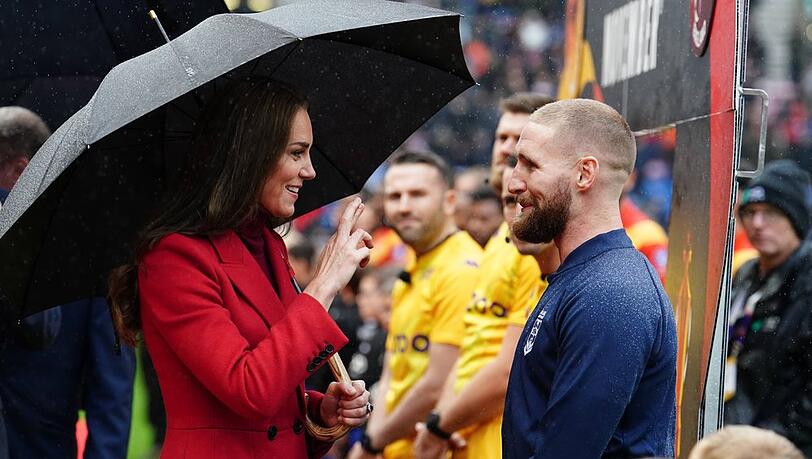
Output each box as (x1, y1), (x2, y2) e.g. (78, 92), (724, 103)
(209, 231), (285, 328)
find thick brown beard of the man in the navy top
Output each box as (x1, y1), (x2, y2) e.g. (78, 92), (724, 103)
(511, 177), (572, 244)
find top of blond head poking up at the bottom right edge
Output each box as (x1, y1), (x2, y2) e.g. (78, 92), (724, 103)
(688, 426), (804, 459)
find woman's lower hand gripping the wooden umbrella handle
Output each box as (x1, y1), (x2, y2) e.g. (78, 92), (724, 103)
(321, 381), (371, 427)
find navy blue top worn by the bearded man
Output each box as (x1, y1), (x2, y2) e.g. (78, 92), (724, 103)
(502, 229), (677, 459)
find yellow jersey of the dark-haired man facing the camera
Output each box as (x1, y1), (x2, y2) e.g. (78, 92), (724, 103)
(384, 231), (482, 458)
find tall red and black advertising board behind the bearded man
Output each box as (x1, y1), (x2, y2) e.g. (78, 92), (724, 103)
(559, 0), (746, 457)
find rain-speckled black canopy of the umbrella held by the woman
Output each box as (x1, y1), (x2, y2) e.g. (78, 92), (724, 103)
(0, 0), (473, 317)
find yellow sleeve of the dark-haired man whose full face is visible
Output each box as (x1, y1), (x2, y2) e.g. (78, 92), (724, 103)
(429, 260), (479, 346)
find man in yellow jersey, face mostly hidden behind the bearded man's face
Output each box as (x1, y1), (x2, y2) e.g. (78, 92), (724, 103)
(415, 164), (559, 459)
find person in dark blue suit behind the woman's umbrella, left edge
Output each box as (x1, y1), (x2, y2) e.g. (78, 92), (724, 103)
(0, 107), (135, 459)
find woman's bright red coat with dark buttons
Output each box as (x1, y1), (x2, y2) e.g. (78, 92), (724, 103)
(138, 230), (347, 459)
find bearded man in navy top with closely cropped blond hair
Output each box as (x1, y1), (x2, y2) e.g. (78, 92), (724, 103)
(502, 99), (677, 459)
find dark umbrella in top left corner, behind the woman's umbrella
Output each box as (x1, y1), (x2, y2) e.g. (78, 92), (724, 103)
(0, 0), (228, 127)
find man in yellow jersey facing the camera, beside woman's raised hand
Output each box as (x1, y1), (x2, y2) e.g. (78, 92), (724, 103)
(349, 152), (482, 459)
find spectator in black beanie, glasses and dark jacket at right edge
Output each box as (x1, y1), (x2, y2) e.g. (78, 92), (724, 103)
(725, 160), (812, 455)
